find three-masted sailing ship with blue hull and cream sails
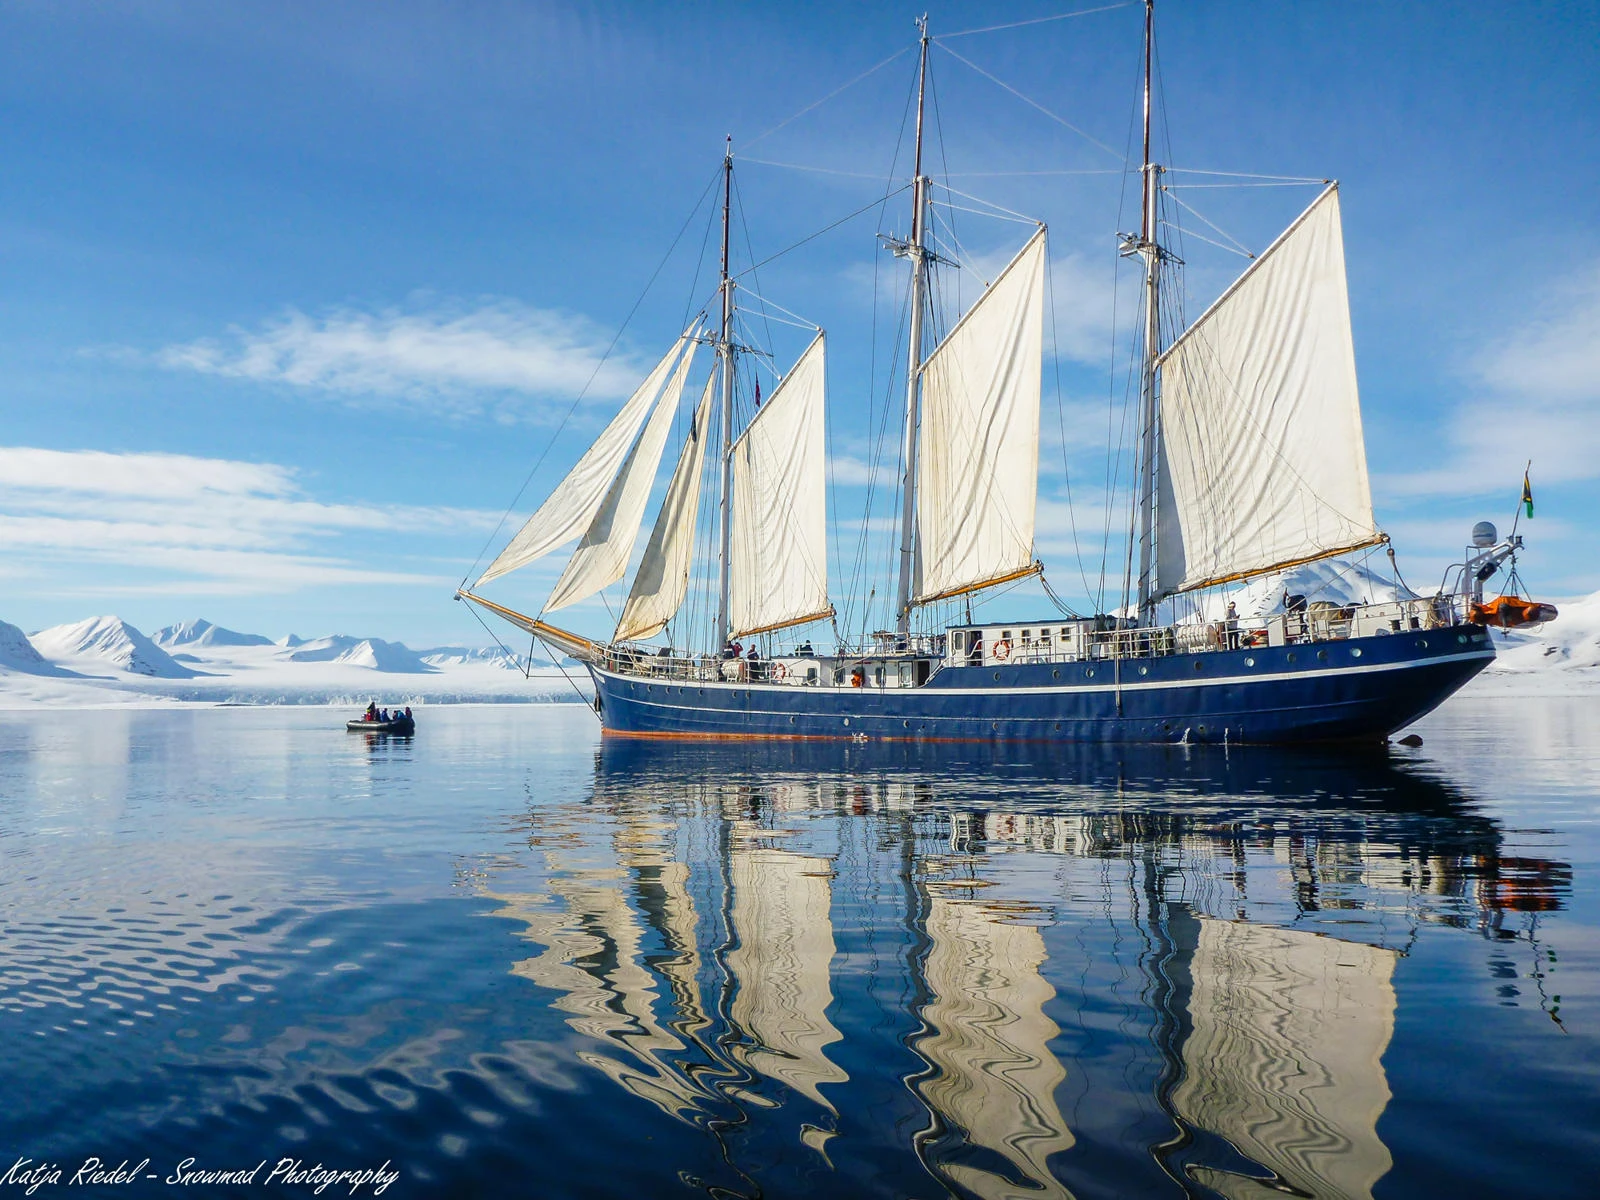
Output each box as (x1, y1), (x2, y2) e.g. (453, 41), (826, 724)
(458, 0), (1520, 744)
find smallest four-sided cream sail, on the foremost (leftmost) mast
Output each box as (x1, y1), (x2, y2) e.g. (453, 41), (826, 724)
(730, 333), (830, 635)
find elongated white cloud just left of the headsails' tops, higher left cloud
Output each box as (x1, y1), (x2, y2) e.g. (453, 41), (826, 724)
(157, 299), (648, 410)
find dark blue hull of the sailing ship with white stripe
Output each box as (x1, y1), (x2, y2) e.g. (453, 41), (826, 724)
(590, 626), (1494, 746)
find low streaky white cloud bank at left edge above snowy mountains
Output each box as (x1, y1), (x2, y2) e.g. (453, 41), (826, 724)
(0, 446), (498, 594)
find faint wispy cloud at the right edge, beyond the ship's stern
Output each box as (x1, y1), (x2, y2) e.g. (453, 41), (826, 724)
(1379, 262), (1600, 496)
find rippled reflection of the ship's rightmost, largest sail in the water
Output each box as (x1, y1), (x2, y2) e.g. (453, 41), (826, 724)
(1173, 917), (1397, 1200)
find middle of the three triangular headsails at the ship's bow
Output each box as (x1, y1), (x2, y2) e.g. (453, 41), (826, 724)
(544, 342), (694, 613)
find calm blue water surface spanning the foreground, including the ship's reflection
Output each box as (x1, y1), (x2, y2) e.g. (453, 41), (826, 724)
(0, 696), (1600, 1200)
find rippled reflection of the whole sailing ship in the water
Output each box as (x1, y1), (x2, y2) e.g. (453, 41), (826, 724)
(467, 741), (1570, 1198)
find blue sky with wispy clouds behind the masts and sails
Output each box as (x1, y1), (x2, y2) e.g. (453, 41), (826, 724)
(0, 0), (1600, 645)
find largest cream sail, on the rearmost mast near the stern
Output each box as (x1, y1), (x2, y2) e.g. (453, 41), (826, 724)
(1157, 184), (1379, 595)
